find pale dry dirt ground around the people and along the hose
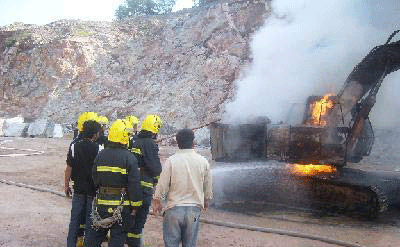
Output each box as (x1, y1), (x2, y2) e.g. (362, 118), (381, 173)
(0, 137), (400, 247)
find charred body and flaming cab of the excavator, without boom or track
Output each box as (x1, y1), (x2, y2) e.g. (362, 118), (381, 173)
(210, 95), (374, 167)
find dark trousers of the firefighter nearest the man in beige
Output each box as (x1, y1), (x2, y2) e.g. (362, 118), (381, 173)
(126, 189), (153, 247)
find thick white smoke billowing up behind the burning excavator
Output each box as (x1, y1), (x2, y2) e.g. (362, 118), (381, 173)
(225, 0), (400, 126)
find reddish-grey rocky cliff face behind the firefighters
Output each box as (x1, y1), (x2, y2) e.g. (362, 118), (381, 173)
(0, 0), (270, 127)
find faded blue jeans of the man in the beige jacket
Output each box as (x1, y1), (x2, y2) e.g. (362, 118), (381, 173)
(163, 206), (201, 247)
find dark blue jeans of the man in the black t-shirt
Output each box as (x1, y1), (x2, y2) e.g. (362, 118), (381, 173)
(67, 194), (93, 247)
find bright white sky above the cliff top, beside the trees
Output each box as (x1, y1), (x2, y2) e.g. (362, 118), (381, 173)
(0, 0), (192, 26)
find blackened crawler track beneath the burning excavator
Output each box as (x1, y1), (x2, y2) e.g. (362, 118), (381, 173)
(290, 168), (400, 218)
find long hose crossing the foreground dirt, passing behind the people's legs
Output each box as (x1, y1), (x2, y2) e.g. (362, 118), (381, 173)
(0, 179), (362, 247)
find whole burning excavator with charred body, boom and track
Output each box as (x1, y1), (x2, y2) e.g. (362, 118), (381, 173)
(211, 30), (400, 216)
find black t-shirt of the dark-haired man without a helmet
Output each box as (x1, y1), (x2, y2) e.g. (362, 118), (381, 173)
(69, 139), (99, 196)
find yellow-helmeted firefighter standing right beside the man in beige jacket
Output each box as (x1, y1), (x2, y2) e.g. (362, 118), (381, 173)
(127, 115), (161, 247)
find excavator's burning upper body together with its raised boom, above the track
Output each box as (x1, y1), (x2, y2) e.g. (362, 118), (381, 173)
(211, 30), (400, 166)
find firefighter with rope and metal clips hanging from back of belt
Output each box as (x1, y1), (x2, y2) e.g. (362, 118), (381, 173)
(85, 119), (142, 247)
